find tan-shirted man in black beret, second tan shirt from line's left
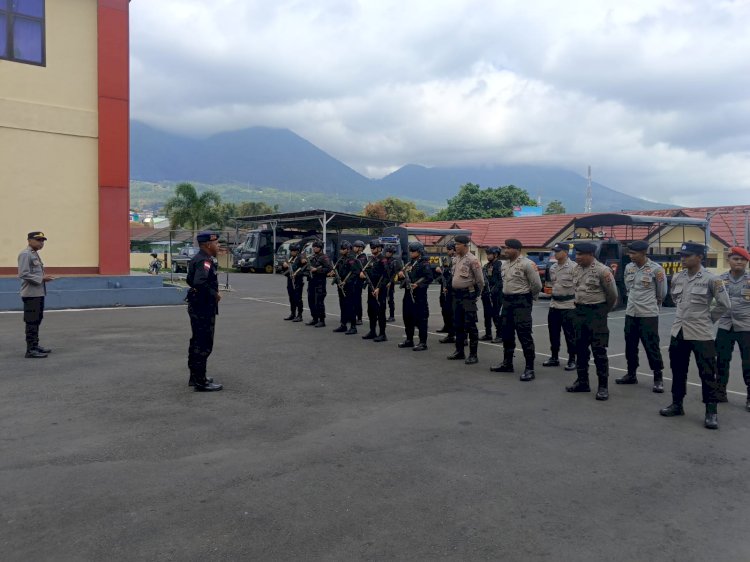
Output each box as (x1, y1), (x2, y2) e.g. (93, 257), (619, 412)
(490, 238), (542, 381)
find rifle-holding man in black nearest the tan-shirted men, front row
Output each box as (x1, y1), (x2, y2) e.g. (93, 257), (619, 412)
(397, 242), (432, 351)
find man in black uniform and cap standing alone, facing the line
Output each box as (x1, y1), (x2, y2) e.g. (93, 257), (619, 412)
(185, 232), (223, 392)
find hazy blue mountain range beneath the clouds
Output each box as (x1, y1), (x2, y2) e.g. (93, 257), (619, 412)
(130, 121), (670, 212)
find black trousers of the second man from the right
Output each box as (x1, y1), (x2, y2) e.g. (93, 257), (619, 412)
(669, 330), (719, 404)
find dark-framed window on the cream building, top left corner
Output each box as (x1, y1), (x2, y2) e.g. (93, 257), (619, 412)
(0, 0), (45, 65)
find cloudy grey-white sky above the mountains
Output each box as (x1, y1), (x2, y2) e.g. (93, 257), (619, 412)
(131, 0), (750, 205)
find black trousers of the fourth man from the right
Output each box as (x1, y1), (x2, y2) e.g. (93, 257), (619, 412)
(575, 303), (609, 380)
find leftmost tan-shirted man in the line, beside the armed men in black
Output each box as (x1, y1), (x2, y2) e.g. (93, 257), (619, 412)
(448, 234), (484, 365)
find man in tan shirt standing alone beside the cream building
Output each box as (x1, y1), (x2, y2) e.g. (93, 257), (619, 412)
(18, 231), (55, 359)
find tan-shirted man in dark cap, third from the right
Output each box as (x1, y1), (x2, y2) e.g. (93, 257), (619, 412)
(615, 240), (667, 393)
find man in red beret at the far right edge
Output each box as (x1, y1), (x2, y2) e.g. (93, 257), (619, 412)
(716, 247), (750, 412)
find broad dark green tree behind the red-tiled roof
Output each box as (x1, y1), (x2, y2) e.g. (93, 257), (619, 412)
(432, 183), (536, 221)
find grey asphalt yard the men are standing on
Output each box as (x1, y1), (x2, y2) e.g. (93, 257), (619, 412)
(0, 274), (750, 561)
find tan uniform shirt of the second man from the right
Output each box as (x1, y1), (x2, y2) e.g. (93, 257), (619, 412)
(671, 266), (731, 341)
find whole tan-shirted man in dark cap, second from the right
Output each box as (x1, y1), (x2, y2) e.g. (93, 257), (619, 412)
(659, 238), (731, 429)
